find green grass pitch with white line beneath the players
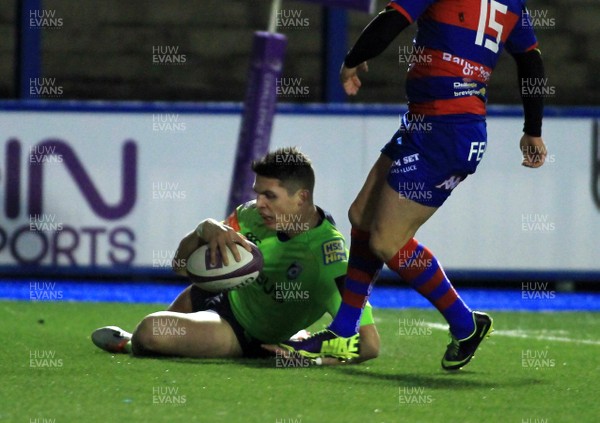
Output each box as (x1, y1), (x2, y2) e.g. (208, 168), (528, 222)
(0, 301), (600, 423)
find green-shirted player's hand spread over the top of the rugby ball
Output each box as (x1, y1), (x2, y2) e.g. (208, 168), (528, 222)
(202, 219), (252, 266)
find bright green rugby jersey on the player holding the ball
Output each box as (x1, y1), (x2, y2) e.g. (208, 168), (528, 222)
(226, 201), (373, 343)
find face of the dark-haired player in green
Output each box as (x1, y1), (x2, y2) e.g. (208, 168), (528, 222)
(254, 175), (303, 230)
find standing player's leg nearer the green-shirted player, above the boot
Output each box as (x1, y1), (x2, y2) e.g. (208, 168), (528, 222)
(329, 154), (392, 338)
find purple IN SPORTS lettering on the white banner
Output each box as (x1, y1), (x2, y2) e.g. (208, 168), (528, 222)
(0, 138), (138, 266)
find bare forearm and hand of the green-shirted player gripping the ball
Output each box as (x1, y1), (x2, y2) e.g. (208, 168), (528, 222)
(172, 219), (250, 276)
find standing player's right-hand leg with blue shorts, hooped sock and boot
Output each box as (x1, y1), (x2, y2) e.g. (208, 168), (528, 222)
(371, 118), (492, 369)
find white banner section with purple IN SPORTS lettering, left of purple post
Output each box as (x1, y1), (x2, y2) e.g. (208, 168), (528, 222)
(0, 112), (239, 268)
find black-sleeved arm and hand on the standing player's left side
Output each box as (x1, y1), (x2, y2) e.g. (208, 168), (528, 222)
(340, 6), (410, 95)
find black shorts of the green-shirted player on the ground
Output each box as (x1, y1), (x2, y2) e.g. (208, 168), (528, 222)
(190, 285), (271, 358)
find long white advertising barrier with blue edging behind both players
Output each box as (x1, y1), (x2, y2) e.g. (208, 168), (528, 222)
(0, 101), (600, 281)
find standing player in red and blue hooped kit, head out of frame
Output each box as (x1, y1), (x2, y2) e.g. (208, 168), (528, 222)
(282, 0), (546, 370)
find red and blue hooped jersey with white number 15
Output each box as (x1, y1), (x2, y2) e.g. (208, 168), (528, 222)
(389, 0), (537, 115)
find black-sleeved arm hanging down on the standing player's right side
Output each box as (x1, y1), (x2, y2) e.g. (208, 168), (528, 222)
(512, 49), (547, 168)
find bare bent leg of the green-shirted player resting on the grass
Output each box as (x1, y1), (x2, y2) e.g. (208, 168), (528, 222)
(132, 311), (243, 358)
